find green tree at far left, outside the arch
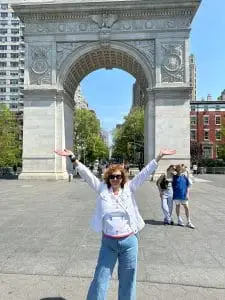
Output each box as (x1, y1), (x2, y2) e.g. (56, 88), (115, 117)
(0, 104), (22, 167)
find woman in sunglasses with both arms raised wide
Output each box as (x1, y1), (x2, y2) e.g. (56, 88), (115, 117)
(55, 149), (176, 300)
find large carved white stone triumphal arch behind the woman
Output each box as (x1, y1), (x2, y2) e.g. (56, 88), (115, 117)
(12, 0), (201, 179)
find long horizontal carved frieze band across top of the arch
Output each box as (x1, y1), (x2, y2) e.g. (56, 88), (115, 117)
(25, 14), (191, 35)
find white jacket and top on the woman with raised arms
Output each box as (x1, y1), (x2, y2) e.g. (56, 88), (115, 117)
(77, 159), (158, 235)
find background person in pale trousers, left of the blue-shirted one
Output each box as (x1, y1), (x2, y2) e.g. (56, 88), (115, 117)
(156, 165), (176, 225)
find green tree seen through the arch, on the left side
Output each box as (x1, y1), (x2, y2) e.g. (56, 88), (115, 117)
(74, 109), (109, 162)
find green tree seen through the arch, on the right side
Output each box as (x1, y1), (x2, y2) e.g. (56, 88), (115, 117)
(112, 108), (144, 162)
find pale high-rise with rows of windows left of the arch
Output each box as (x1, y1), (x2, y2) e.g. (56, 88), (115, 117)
(0, 0), (25, 112)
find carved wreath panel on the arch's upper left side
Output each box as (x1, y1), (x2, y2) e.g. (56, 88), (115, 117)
(29, 45), (52, 85)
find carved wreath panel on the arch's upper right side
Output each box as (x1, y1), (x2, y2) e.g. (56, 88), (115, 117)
(161, 41), (185, 83)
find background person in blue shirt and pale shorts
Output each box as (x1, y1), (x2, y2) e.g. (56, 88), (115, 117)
(172, 165), (195, 229)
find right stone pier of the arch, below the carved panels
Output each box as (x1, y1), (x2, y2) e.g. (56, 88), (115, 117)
(145, 87), (190, 177)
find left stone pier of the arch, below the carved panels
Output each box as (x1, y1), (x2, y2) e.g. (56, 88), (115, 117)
(19, 89), (73, 180)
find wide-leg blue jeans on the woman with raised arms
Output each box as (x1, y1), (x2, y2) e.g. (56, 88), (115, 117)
(87, 234), (138, 300)
